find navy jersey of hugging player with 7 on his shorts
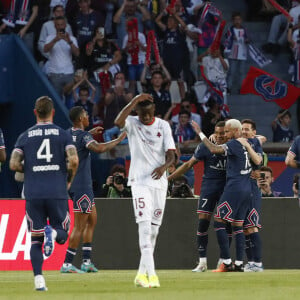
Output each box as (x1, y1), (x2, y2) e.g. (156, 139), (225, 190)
(194, 143), (227, 192)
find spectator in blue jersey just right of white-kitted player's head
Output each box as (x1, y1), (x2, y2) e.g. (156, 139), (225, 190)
(173, 110), (199, 147)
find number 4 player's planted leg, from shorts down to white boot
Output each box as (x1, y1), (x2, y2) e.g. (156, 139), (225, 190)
(26, 200), (47, 291)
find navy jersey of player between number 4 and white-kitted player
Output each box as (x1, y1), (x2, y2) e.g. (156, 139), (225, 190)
(69, 128), (94, 192)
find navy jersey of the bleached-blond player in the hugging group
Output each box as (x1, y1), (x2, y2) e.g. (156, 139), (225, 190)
(223, 139), (252, 190)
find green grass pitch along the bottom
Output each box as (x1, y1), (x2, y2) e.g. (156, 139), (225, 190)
(0, 270), (300, 300)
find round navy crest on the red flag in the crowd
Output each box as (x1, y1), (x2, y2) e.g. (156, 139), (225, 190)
(254, 75), (288, 102)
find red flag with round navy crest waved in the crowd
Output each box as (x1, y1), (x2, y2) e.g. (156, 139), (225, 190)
(241, 67), (300, 109)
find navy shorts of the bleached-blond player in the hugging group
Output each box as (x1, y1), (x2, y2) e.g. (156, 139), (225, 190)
(215, 190), (251, 223)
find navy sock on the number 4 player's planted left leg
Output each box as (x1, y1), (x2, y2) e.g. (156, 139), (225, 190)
(30, 236), (44, 276)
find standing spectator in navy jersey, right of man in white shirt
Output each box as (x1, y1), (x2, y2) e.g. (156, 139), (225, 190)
(75, 0), (105, 68)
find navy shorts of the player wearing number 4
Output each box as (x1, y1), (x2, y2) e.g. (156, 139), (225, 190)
(26, 199), (71, 233)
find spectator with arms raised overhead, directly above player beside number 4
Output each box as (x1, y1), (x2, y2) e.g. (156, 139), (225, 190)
(73, 85), (95, 129)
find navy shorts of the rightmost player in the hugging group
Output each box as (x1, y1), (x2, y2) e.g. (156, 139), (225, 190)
(244, 185), (261, 228)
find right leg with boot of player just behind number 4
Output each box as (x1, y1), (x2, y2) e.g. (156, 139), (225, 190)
(81, 205), (98, 272)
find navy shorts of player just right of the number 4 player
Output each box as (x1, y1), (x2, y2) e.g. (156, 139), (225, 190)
(70, 190), (95, 214)
